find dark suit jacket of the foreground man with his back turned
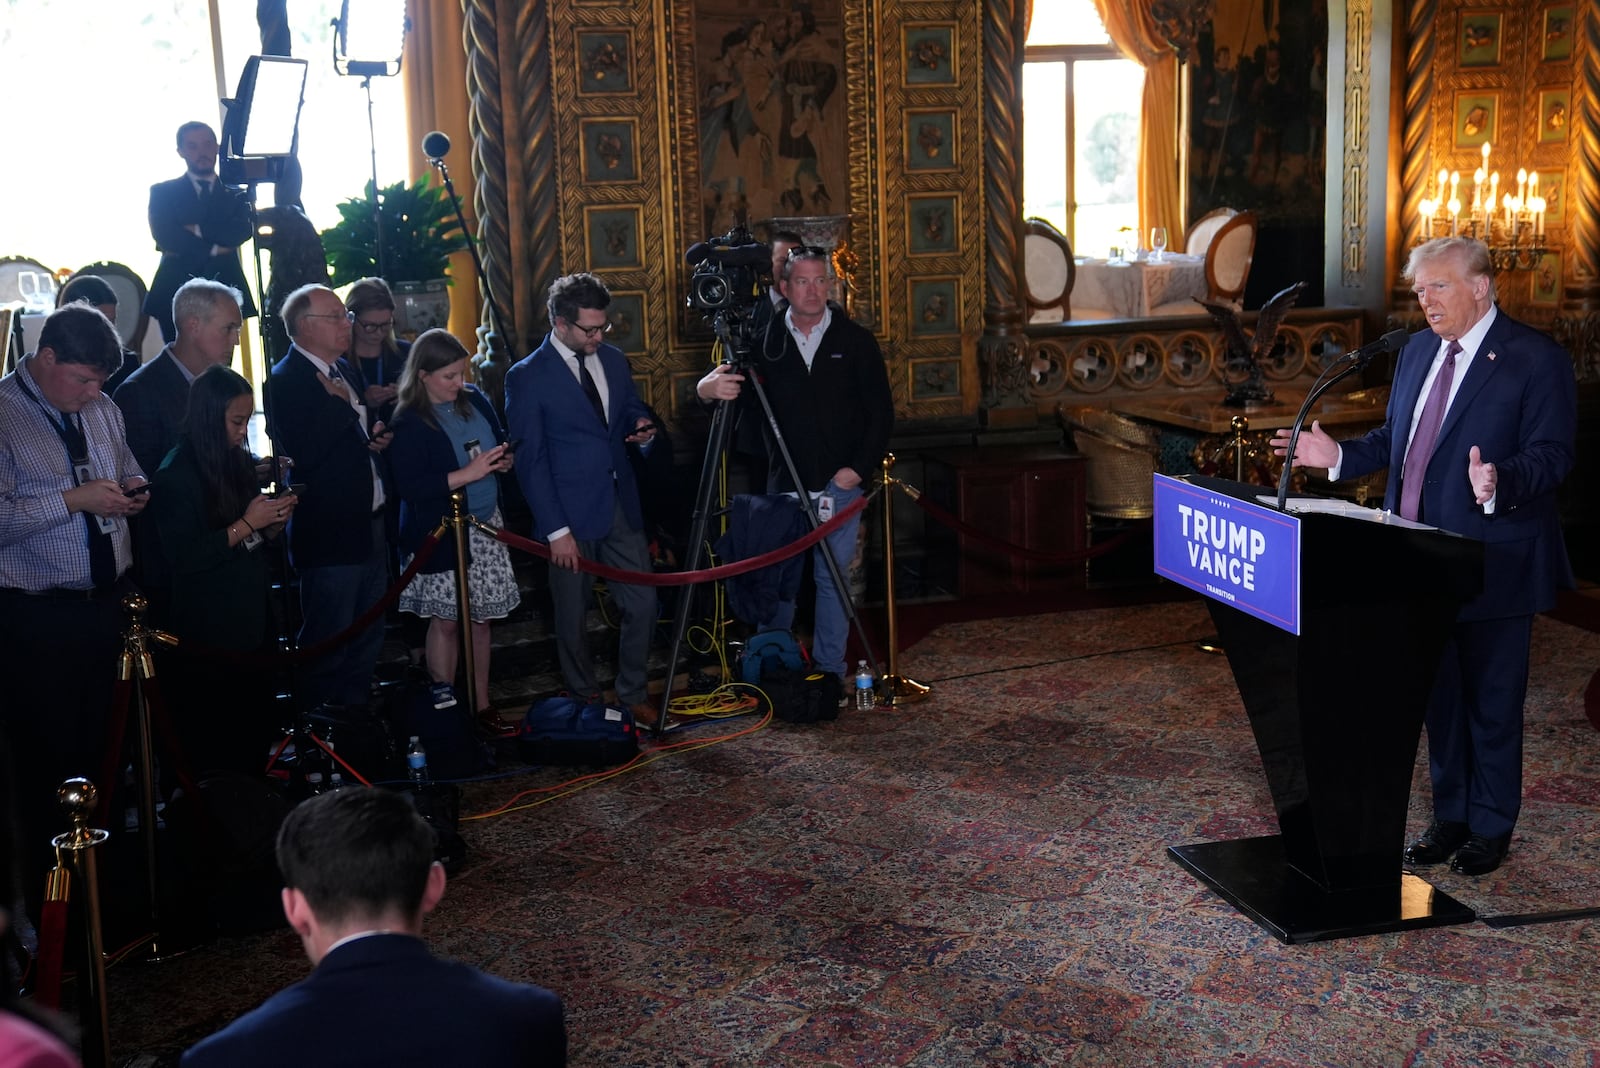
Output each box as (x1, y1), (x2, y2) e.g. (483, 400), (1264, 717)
(181, 934), (566, 1068)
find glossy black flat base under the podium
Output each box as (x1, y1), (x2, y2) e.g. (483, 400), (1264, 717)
(1166, 835), (1477, 945)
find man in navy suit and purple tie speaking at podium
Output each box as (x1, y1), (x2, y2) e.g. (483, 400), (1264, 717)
(1272, 237), (1578, 876)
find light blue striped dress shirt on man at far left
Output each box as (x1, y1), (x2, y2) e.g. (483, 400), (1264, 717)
(0, 357), (144, 593)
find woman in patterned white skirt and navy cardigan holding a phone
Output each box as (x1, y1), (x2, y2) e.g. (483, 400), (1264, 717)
(389, 329), (520, 731)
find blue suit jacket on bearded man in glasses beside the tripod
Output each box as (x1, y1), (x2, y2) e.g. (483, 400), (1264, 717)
(506, 337), (650, 542)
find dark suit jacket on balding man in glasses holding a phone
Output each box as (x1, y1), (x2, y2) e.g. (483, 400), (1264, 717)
(266, 347), (382, 568)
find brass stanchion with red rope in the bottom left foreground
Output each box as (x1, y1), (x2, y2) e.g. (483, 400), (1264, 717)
(35, 779), (110, 1068)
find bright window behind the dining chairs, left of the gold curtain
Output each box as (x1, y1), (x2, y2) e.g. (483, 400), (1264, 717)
(1022, 0), (1144, 256)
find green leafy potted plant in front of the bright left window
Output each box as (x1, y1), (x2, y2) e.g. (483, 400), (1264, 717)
(322, 176), (467, 337)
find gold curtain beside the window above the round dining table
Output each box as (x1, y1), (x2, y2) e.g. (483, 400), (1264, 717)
(1094, 0), (1184, 245)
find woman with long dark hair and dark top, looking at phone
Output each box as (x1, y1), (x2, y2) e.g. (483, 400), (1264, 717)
(149, 366), (294, 769)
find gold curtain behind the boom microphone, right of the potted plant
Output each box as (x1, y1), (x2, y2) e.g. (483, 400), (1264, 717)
(402, 0), (483, 343)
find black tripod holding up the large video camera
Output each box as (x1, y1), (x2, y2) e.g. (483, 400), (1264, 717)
(656, 297), (878, 735)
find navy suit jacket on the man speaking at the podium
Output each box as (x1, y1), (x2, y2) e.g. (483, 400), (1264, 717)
(1339, 312), (1578, 620)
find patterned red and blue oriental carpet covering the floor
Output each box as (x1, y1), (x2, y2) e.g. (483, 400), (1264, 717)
(109, 601), (1600, 1068)
